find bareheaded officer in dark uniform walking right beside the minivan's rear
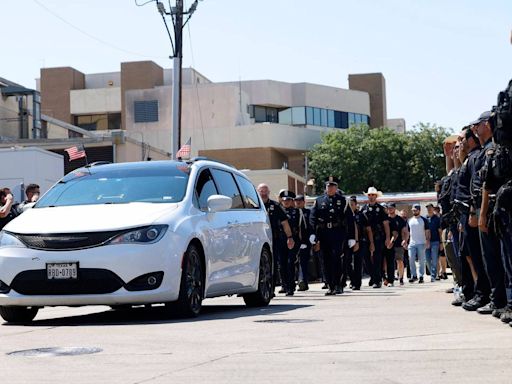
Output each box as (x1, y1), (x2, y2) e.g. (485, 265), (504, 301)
(256, 183), (295, 293)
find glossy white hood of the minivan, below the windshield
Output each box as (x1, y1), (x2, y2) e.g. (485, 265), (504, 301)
(4, 202), (178, 234)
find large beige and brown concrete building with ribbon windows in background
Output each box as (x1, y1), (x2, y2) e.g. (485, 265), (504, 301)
(37, 61), (404, 198)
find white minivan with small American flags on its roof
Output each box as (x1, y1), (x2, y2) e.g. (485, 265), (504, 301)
(0, 158), (273, 322)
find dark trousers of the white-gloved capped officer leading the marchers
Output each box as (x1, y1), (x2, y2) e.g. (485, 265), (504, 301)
(319, 228), (345, 289)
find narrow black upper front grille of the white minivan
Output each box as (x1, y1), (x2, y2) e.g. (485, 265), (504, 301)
(11, 231), (126, 251)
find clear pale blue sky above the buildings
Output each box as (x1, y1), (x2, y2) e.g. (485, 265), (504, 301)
(0, 0), (512, 130)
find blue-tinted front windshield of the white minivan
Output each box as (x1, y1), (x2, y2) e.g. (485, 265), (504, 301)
(35, 166), (189, 208)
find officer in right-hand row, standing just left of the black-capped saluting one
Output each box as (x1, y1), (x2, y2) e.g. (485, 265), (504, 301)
(455, 127), (491, 311)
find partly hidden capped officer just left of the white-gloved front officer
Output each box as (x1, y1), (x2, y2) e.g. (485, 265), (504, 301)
(295, 195), (313, 291)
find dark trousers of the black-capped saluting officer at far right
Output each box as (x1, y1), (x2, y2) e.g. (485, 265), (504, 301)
(480, 226), (507, 308)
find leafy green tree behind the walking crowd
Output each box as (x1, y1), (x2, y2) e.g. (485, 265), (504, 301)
(309, 124), (449, 193)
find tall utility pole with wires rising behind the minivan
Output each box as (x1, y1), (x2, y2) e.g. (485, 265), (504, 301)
(156, 0), (202, 159)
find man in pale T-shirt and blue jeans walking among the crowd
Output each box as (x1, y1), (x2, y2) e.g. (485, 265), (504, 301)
(407, 204), (430, 284)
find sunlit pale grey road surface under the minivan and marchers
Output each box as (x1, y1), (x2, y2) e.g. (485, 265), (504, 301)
(0, 282), (512, 384)
